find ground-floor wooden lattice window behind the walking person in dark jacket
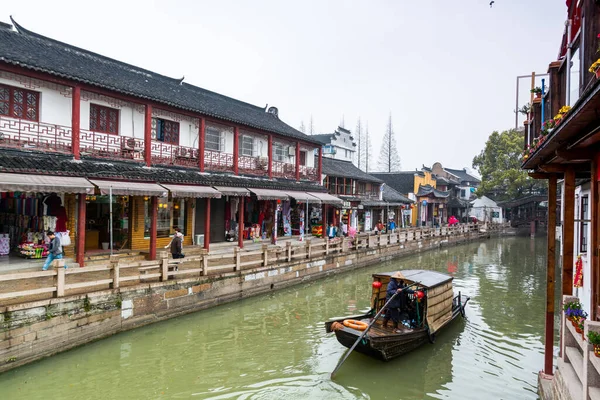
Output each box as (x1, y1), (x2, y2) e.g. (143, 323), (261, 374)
(144, 197), (187, 238)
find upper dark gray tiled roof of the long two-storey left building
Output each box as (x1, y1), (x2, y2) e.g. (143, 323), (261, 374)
(0, 20), (318, 143)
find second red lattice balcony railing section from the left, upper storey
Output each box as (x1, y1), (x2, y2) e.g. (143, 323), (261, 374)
(79, 129), (144, 161)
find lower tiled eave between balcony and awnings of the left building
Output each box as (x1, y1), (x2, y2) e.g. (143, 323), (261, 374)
(0, 149), (325, 192)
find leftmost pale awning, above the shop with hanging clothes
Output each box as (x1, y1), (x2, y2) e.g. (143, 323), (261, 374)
(0, 173), (94, 193)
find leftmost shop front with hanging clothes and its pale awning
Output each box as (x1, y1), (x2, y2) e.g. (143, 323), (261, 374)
(0, 173), (93, 269)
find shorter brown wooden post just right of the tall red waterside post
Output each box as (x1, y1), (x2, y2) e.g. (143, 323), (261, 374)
(562, 166), (575, 296)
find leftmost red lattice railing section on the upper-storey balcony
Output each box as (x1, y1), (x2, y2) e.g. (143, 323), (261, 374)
(0, 117), (71, 153)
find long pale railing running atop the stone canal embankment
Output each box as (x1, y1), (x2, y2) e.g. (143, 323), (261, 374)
(0, 224), (506, 305)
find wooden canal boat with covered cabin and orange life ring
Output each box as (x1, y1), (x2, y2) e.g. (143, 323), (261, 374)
(325, 270), (469, 361)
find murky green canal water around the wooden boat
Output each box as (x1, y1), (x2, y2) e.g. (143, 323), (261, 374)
(0, 238), (546, 400)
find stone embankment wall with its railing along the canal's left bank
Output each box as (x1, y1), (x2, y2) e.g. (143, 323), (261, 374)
(0, 225), (506, 372)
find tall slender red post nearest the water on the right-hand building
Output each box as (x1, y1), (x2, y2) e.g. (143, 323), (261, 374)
(544, 175), (557, 375)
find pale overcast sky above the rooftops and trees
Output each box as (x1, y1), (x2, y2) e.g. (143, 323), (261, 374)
(1, 0), (566, 170)
